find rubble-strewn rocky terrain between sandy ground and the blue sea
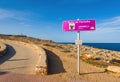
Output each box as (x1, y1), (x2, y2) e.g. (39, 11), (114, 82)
(44, 40), (120, 67)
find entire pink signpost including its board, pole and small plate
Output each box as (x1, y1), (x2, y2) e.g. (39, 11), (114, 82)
(63, 20), (96, 74)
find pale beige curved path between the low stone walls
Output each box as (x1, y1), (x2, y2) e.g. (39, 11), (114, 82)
(0, 42), (38, 74)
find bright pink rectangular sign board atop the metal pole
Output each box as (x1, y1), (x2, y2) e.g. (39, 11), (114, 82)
(63, 20), (95, 31)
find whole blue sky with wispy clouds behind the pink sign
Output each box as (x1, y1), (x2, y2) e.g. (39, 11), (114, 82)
(0, 0), (120, 43)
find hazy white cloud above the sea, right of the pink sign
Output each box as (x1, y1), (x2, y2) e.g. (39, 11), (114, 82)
(81, 16), (120, 42)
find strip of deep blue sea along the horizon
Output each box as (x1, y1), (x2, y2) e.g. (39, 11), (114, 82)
(58, 42), (120, 51)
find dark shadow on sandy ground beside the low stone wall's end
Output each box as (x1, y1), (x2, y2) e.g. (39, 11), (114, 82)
(45, 49), (65, 75)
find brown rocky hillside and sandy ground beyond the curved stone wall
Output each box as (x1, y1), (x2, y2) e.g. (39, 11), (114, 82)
(0, 35), (120, 82)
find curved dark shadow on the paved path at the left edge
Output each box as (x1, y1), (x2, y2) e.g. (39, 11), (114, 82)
(0, 45), (16, 64)
